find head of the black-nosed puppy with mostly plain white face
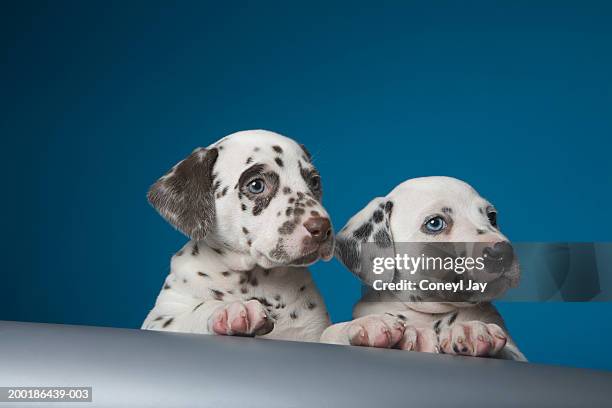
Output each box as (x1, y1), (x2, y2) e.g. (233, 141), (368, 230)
(336, 177), (520, 302)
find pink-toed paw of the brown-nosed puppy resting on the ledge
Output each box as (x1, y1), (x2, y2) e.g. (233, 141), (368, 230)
(208, 300), (274, 336)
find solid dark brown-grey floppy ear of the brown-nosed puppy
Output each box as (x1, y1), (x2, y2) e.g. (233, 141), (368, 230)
(147, 147), (219, 240)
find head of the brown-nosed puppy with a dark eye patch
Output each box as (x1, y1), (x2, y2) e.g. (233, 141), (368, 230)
(148, 130), (334, 268)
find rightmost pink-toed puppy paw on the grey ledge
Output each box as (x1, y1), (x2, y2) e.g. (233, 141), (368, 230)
(439, 321), (508, 357)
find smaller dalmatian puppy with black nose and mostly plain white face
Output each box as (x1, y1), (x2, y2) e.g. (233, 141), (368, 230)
(321, 177), (526, 361)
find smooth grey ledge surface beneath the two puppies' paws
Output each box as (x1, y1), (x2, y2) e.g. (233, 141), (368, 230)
(0, 321), (612, 408)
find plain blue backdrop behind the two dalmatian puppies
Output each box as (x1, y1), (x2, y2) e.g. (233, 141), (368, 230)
(0, 1), (612, 369)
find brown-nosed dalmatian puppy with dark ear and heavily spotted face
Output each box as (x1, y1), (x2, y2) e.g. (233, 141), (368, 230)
(142, 130), (334, 341)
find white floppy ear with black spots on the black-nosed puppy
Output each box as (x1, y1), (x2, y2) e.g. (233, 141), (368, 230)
(335, 197), (395, 285)
